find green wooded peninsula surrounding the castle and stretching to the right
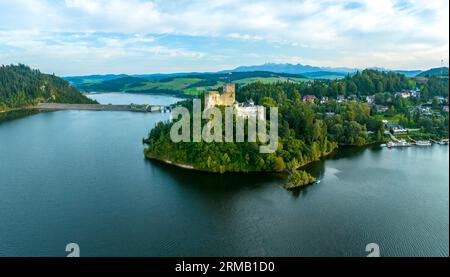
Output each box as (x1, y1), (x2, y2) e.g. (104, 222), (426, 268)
(144, 70), (448, 186)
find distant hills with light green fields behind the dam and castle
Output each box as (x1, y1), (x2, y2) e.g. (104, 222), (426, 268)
(70, 71), (308, 97)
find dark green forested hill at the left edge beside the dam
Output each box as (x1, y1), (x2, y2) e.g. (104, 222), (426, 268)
(0, 64), (95, 111)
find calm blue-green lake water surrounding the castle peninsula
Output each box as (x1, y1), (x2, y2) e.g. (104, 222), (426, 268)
(0, 94), (449, 256)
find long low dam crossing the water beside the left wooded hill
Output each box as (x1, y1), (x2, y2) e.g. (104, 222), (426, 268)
(35, 103), (166, 113)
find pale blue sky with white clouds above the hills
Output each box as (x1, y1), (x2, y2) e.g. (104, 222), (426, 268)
(0, 0), (449, 76)
